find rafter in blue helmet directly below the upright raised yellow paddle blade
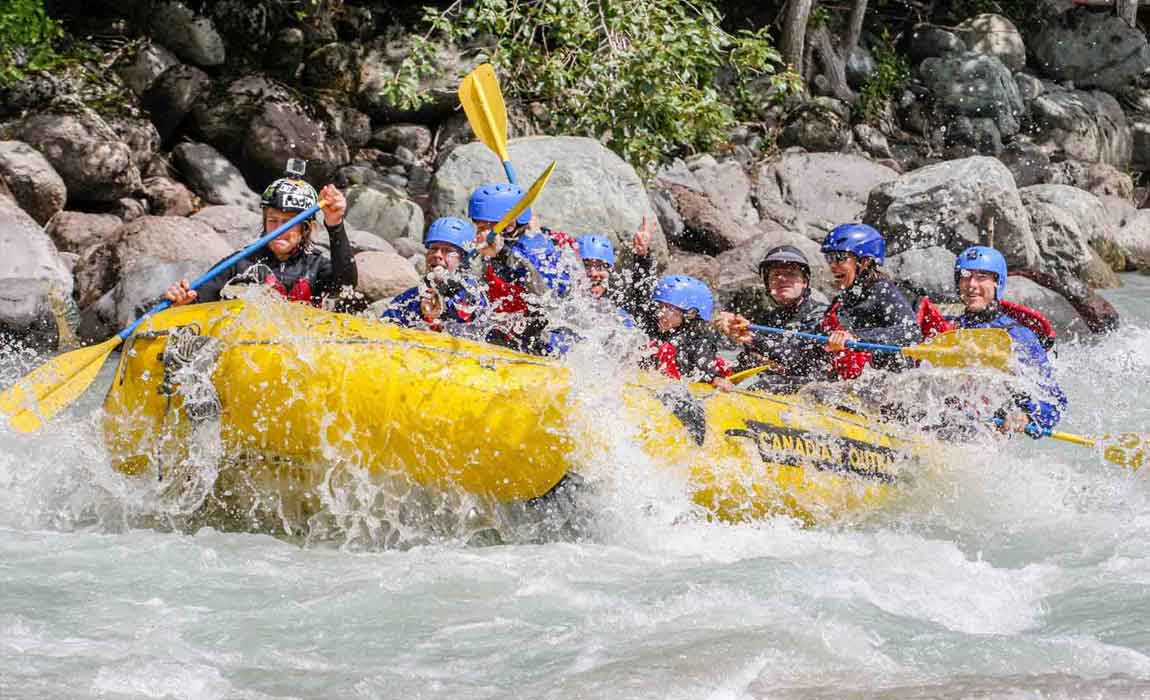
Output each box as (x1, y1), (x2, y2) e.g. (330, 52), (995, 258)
(467, 183), (572, 355)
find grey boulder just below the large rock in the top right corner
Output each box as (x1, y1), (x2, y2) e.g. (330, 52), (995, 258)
(1030, 84), (1133, 168)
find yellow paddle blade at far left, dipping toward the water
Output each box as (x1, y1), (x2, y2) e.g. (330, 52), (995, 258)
(0, 336), (121, 432)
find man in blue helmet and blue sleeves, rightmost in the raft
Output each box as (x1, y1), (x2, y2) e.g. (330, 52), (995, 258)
(951, 246), (1067, 438)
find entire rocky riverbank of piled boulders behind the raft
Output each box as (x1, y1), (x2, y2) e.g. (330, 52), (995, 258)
(0, 0), (1150, 344)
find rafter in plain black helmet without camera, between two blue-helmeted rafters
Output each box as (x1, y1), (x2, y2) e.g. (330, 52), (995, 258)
(714, 245), (830, 388)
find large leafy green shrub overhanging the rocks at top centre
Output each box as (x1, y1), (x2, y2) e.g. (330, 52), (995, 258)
(384, 0), (796, 170)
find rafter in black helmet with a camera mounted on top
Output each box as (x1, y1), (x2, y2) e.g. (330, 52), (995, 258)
(164, 168), (359, 306)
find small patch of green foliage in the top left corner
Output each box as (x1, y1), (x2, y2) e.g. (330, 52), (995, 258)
(0, 0), (64, 83)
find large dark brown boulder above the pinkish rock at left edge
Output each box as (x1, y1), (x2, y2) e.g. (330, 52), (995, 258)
(15, 107), (140, 202)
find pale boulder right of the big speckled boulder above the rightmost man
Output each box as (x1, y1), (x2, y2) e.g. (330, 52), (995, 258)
(1019, 185), (1118, 287)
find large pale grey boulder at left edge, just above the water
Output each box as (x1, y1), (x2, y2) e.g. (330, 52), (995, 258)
(0, 198), (72, 344)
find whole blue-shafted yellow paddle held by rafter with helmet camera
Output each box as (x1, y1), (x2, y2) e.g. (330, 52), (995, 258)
(0, 200), (327, 432)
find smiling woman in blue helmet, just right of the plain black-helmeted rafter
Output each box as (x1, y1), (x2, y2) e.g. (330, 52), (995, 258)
(821, 223), (922, 379)
